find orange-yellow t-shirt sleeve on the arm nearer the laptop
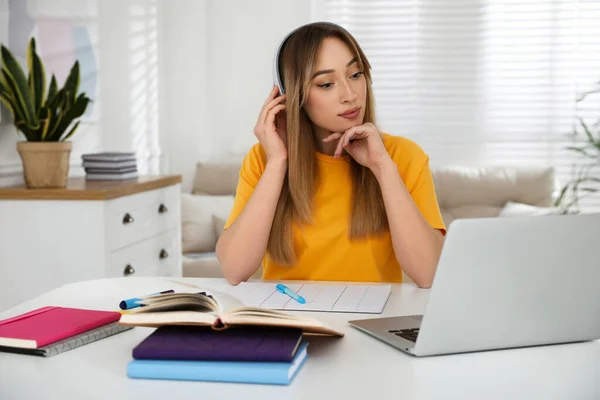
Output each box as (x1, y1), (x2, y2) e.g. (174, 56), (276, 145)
(409, 153), (446, 235)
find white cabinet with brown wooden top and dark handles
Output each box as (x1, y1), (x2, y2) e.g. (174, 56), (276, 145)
(0, 176), (181, 311)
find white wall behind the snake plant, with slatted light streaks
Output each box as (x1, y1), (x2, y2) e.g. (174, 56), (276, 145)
(0, 0), (161, 186)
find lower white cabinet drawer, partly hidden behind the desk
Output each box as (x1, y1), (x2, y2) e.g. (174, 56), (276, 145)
(106, 229), (181, 277)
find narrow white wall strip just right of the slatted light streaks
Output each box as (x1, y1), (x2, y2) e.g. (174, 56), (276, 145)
(159, 0), (212, 191)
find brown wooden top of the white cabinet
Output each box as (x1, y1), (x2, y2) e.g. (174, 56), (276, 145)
(0, 175), (181, 200)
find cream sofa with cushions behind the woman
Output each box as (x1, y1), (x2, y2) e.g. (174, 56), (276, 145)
(181, 162), (558, 278)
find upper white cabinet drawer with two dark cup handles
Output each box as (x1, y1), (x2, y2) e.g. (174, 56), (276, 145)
(105, 185), (180, 251)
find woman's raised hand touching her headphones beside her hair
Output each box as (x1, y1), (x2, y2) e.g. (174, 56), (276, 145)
(254, 86), (287, 162)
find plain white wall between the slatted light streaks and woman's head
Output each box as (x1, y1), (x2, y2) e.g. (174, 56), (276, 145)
(161, 0), (311, 191)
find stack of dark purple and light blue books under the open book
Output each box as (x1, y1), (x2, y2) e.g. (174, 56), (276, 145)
(127, 325), (308, 385)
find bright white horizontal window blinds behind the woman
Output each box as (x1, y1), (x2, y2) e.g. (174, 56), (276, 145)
(313, 0), (600, 211)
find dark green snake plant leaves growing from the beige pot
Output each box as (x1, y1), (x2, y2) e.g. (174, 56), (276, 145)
(0, 38), (91, 142)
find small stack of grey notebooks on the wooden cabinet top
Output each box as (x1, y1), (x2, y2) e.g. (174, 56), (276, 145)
(81, 152), (138, 181)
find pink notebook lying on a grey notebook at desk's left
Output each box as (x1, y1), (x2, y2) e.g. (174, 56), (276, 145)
(0, 307), (121, 349)
